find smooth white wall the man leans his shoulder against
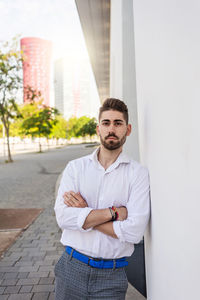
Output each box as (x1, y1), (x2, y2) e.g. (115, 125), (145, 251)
(133, 0), (200, 300)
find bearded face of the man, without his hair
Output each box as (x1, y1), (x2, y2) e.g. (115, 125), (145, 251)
(97, 110), (131, 150)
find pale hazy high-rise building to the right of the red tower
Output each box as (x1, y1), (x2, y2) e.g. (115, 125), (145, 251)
(54, 55), (100, 119)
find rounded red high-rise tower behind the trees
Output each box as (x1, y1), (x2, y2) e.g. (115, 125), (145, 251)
(21, 37), (52, 105)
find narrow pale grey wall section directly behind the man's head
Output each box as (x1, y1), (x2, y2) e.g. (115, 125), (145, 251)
(110, 0), (139, 160)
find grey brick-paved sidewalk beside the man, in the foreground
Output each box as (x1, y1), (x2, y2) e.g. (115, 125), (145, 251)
(0, 203), (145, 300)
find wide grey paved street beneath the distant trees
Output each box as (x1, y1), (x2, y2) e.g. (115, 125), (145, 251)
(0, 145), (94, 208)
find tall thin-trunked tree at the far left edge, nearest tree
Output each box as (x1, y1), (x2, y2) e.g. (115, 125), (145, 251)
(0, 38), (22, 162)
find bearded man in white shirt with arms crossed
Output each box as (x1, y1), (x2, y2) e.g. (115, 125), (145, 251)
(55, 98), (149, 300)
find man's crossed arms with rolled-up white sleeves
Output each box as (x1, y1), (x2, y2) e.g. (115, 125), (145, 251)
(54, 163), (150, 244)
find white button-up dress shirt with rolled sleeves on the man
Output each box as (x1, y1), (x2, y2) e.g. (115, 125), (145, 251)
(54, 149), (150, 259)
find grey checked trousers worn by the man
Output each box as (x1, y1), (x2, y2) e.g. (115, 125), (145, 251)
(55, 252), (128, 300)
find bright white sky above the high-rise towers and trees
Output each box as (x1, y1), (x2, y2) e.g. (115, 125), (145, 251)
(0, 0), (99, 115)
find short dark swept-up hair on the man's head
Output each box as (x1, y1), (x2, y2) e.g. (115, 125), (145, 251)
(99, 98), (128, 124)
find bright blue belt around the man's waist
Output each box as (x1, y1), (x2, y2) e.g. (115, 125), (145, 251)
(65, 246), (128, 269)
